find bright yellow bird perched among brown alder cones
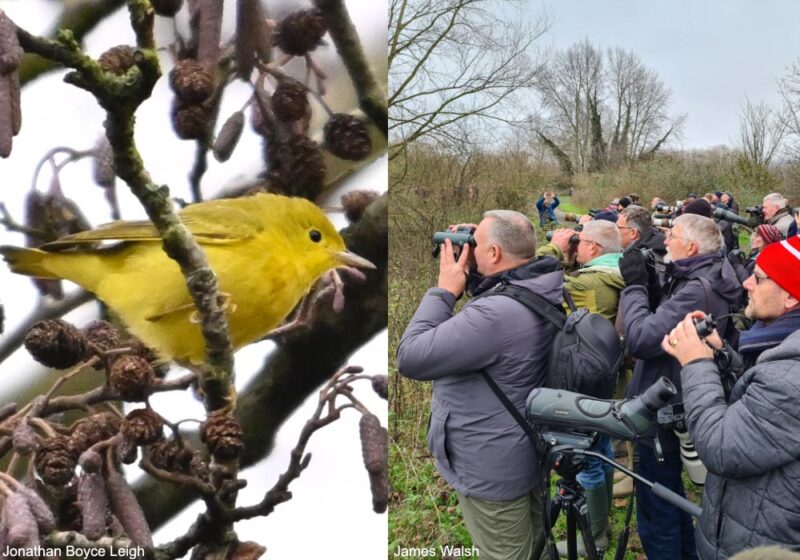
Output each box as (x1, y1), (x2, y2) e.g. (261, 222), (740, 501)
(0, 194), (374, 364)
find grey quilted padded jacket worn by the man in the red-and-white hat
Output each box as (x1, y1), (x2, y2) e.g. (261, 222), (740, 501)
(681, 332), (800, 560)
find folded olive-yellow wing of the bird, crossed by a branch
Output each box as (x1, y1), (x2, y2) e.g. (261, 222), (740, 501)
(41, 200), (263, 247)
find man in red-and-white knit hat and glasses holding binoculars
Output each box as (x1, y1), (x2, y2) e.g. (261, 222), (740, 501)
(661, 237), (800, 560)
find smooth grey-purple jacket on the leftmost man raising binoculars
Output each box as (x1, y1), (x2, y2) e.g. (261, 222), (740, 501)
(397, 257), (563, 501)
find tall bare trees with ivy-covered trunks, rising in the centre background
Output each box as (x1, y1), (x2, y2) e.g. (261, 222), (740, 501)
(537, 39), (685, 171)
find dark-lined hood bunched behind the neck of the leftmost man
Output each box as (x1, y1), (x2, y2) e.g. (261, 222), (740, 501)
(469, 256), (564, 304)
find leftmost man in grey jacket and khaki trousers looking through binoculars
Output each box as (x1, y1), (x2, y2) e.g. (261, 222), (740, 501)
(397, 210), (563, 560)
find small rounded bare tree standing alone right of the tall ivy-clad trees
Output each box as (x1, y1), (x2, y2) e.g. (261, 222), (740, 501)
(739, 99), (791, 168)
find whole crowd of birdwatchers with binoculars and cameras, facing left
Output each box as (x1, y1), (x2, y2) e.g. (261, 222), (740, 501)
(397, 191), (800, 560)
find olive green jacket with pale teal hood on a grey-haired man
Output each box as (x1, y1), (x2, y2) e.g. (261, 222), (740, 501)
(537, 243), (625, 323)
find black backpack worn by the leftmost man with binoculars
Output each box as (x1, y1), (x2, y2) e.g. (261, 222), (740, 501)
(478, 283), (623, 399)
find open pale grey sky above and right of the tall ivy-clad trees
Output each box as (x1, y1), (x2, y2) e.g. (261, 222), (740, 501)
(531, 0), (800, 148)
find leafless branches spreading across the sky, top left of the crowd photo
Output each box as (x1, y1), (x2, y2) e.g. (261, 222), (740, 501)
(389, 0), (548, 158)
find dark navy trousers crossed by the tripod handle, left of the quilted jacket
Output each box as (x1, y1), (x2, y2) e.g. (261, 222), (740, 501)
(636, 444), (698, 560)
